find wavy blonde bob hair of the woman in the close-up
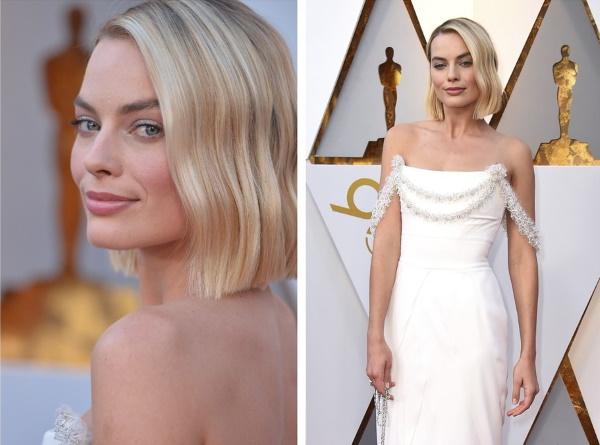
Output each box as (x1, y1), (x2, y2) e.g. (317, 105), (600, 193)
(96, 0), (297, 298)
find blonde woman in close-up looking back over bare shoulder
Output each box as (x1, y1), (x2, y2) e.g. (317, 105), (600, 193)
(45, 0), (296, 445)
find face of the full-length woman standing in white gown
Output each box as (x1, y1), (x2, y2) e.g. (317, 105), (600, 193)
(430, 32), (479, 108)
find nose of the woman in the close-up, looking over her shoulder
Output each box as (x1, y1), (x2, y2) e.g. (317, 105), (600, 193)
(83, 128), (122, 177)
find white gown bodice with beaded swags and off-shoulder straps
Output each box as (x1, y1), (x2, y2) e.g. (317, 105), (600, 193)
(371, 155), (539, 260)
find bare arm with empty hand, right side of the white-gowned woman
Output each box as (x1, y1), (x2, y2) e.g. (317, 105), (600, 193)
(506, 141), (539, 416)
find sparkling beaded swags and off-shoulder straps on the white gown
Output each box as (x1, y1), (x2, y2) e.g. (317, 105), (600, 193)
(371, 155), (541, 252)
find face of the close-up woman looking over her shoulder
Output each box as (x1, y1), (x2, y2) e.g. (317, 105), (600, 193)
(71, 38), (185, 249)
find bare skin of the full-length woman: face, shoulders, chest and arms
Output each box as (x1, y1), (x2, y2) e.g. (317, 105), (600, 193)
(367, 33), (539, 416)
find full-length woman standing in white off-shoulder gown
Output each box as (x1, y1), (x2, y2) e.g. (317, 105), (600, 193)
(367, 18), (539, 445)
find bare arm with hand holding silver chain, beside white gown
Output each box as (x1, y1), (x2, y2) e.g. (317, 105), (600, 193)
(367, 127), (403, 394)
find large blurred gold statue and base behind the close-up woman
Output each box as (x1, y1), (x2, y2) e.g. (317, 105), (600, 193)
(1, 7), (138, 365)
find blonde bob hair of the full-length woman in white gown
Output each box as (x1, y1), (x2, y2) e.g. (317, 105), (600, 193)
(425, 17), (503, 121)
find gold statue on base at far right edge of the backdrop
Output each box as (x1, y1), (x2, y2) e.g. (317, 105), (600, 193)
(533, 45), (600, 165)
